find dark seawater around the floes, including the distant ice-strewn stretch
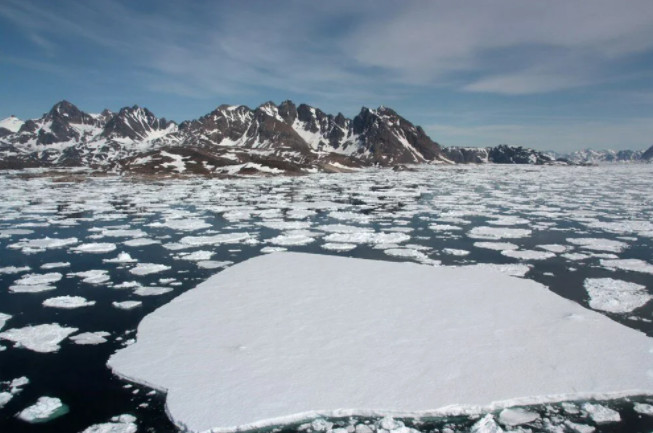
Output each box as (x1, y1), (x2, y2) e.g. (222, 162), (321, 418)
(0, 166), (653, 432)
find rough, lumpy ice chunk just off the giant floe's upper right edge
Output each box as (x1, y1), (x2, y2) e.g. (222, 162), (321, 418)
(584, 278), (653, 313)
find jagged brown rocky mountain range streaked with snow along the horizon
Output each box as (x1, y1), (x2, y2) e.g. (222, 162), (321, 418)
(0, 101), (653, 175)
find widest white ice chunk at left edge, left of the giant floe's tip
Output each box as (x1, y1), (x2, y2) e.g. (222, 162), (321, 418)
(0, 323), (77, 353)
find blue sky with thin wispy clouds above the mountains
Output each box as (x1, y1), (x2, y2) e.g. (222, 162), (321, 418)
(0, 0), (653, 152)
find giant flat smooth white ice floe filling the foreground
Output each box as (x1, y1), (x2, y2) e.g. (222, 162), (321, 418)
(109, 253), (653, 431)
